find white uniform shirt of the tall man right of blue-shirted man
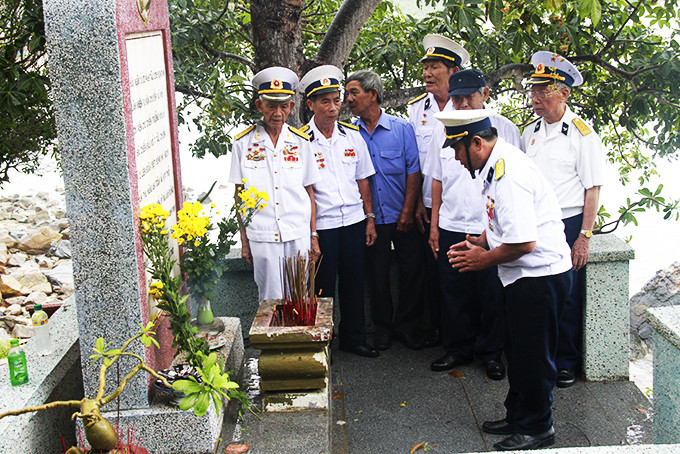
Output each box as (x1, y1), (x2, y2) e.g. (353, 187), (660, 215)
(408, 92), (456, 208)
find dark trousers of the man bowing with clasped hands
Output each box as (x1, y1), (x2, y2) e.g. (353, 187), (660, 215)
(504, 271), (571, 435)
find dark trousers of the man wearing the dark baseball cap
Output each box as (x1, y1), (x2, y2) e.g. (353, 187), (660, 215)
(437, 229), (505, 361)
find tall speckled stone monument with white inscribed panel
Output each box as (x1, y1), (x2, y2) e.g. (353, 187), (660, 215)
(44, 0), (242, 453)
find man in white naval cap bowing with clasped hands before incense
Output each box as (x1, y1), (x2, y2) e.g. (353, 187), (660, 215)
(437, 109), (571, 451)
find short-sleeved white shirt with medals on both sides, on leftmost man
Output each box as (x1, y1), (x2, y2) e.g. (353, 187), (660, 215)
(229, 125), (319, 242)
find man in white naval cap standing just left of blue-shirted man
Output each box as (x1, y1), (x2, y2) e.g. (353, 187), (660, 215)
(299, 65), (379, 358)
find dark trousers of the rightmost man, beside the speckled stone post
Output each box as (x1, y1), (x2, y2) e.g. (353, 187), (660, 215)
(556, 214), (585, 370)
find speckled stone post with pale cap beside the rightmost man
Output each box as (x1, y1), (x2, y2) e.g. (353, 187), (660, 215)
(583, 235), (634, 381)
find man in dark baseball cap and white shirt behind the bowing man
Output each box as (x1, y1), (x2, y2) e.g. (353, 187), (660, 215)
(423, 69), (520, 380)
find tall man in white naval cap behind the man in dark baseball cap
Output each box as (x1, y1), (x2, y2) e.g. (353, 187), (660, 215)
(408, 34), (470, 347)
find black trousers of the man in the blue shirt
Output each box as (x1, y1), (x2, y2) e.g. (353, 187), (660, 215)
(366, 223), (425, 335)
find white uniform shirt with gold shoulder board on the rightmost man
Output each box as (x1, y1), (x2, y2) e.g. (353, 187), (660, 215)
(522, 106), (604, 219)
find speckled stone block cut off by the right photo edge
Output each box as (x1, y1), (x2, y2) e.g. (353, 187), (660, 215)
(647, 306), (680, 443)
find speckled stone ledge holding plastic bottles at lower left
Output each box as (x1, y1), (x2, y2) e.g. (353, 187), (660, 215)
(0, 297), (83, 454)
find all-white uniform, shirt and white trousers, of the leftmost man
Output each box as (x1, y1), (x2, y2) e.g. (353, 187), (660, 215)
(229, 125), (319, 300)
